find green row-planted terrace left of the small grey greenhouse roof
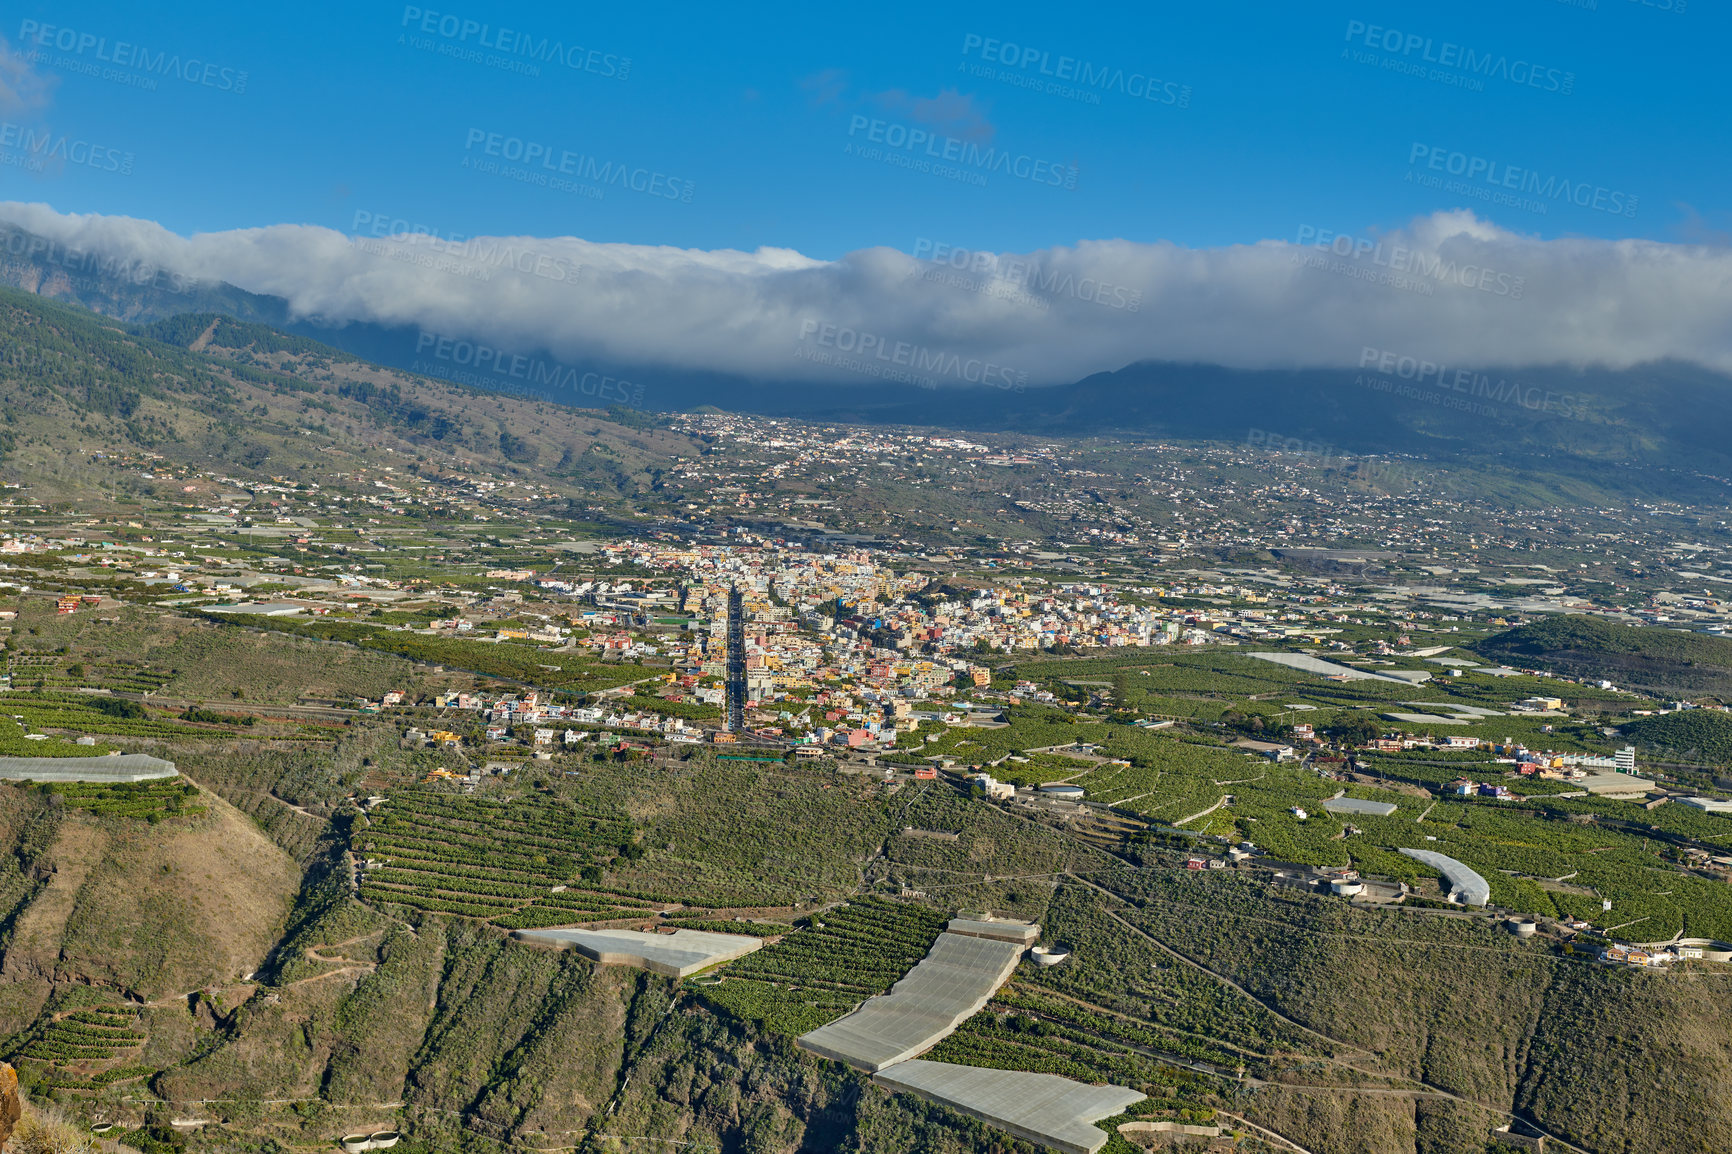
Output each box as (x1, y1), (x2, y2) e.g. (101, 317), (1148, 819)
(352, 790), (651, 929)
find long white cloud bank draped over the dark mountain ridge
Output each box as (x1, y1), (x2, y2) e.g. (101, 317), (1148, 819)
(0, 203), (1732, 385)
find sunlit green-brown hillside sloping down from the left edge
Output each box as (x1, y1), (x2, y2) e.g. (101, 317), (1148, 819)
(0, 289), (700, 502)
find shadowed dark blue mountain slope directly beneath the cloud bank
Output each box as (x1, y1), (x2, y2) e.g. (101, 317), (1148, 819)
(0, 218), (1732, 499)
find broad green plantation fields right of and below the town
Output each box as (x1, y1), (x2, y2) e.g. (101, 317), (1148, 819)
(927, 706), (1732, 941)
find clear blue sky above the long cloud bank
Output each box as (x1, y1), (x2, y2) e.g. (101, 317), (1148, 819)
(0, 0), (1732, 258)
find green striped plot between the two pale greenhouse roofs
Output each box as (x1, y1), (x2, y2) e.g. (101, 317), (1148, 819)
(701, 898), (946, 1038)
